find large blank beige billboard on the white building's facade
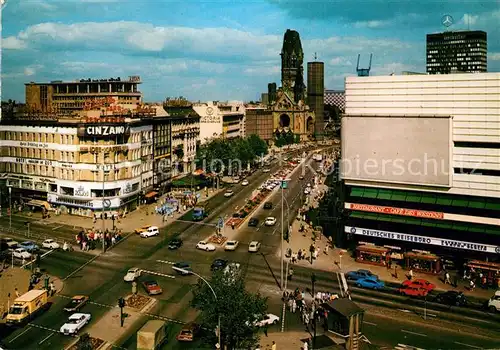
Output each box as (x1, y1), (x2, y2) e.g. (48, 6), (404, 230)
(340, 115), (452, 187)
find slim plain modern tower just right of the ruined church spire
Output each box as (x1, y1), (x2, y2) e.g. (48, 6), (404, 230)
(307, 62), (325, 138)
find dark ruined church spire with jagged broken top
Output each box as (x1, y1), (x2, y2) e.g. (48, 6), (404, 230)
(281, 29), (305, 103)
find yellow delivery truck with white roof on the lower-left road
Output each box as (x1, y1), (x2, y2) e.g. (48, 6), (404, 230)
(6, 289), (48, 326)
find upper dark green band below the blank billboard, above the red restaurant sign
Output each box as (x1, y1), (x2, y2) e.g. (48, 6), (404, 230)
(351, 187), (500, 211)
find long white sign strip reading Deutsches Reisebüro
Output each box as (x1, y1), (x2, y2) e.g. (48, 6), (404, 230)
(345, 226), (500, 254)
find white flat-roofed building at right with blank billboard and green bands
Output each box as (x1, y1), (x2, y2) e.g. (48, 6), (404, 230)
(337, 73), (500, 273)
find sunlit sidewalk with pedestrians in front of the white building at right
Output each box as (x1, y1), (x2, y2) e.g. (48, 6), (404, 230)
(276, 180), (494, 299)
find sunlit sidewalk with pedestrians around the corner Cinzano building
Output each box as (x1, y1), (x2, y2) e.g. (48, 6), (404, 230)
(31, 189), (221, 232)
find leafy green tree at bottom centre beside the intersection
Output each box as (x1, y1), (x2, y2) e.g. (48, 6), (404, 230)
(191, 271), (267, 350)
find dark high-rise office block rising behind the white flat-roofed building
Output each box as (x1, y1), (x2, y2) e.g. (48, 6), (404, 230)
(427, 30), (488, 74)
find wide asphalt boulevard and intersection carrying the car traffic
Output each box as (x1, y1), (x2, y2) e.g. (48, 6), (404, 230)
(2, 149), (500, 349)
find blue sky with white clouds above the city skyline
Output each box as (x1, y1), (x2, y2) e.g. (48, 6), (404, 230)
(2, 0), (500, 101)
